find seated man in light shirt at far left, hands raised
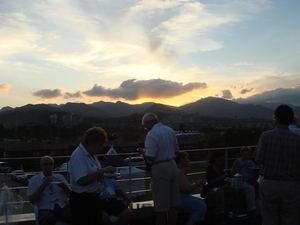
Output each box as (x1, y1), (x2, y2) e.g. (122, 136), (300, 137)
(27, 156), (72, 225)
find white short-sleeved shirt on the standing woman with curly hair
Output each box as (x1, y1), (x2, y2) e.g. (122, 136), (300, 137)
(70, 144), (101, 193)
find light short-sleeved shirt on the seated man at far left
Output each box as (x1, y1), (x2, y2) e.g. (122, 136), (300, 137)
(26, 173), (68, 210)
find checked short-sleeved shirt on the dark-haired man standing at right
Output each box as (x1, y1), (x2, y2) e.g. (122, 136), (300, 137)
(253, 125), (300, 180)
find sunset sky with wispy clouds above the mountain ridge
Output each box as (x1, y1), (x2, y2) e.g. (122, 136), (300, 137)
(0, 0), (300, 109)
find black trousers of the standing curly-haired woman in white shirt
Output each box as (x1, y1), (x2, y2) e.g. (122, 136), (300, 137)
(69, 191), (103, 225)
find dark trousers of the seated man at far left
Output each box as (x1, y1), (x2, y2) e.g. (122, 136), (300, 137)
(38, 204), (72, 225)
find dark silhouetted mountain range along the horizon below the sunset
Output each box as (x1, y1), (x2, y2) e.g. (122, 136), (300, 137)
(0, 97), (300, 125)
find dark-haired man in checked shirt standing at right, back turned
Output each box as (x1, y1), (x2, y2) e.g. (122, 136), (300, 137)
(253, 105), (300, 225)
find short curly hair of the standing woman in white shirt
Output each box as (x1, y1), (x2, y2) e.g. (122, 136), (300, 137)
(81, 127), (107, 147)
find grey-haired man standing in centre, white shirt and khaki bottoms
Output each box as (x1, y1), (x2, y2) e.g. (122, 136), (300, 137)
(137, 113), (180, 225)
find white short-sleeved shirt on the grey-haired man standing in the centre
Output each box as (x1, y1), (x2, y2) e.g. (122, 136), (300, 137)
(145, 123), (179, 162)
